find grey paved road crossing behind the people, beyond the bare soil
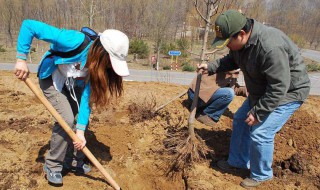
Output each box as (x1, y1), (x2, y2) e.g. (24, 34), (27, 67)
(0, 63), (320, 95)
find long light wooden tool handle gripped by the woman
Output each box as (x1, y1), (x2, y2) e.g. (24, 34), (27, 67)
(24, 78), (121, 190)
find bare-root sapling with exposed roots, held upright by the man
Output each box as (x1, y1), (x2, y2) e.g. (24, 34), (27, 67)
(164, 0), (239, 175)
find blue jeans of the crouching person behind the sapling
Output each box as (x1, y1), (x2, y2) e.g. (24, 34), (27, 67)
(188, 88), (234, 122)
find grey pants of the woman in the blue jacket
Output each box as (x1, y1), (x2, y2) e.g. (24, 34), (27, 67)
(39, 76), (84, 172)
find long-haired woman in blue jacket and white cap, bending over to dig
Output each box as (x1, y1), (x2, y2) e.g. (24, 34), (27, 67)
(14, 20), (129, 184)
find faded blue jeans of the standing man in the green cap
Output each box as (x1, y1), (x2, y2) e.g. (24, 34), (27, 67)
(228, 99), (302, 181)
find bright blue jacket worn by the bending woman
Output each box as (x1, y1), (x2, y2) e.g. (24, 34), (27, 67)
(16, 20), (93, 130)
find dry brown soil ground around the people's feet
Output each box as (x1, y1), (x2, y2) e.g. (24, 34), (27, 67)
(0, 71), (320, 190)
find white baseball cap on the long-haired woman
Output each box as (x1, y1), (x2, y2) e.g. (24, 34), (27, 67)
(100, 29), (130, 77)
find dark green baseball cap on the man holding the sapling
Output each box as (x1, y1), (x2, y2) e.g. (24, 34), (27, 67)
(212, 10), (247, 49)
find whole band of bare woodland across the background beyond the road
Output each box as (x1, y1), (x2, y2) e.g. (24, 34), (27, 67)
(0, 0), (320, 61)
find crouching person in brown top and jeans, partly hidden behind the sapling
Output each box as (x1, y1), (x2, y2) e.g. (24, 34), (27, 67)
(188, 70), (247, 127)
